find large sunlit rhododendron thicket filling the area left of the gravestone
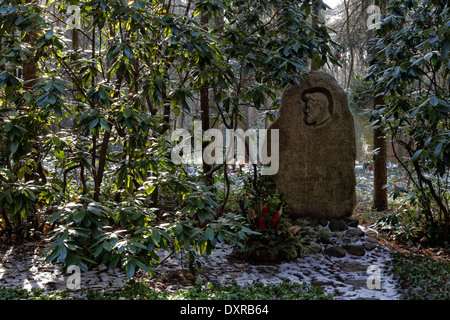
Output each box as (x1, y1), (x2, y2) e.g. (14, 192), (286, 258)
(0, 0), (336, 277)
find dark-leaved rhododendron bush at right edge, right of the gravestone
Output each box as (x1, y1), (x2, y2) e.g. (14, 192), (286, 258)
(369, 0), (450, 243)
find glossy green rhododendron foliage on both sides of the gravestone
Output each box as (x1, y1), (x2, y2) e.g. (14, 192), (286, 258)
(0, 0), (450, 277)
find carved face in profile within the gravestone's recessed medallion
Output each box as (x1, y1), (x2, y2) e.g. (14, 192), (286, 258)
(304, 92), (331, 126)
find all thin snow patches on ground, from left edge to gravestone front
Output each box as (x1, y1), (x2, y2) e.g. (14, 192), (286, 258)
(0, 226), (400, 300)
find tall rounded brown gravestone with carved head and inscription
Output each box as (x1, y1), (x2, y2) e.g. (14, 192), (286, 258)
(269, 71), (356, 220)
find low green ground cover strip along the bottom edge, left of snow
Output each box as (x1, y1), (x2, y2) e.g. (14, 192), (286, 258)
(0, 279), (333, 300)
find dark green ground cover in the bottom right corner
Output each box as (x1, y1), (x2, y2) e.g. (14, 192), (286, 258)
(392, 252), (450, 300)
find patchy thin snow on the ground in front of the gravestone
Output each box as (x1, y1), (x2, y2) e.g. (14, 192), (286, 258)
(208, 248), (399, 300)
